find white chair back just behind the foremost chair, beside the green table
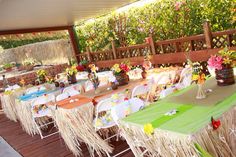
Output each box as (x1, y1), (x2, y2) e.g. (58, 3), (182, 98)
(131, 85), (150, 102)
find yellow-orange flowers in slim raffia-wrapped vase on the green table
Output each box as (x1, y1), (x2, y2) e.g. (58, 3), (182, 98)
(192, 64), (206, 99)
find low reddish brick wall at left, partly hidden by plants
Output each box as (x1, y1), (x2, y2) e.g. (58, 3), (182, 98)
(0, 64), (68, 88)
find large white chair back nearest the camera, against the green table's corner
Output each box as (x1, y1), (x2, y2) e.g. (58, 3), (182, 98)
(111, 98), (145, 124)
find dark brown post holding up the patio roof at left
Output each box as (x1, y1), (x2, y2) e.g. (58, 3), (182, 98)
(68, 26), (80, 64)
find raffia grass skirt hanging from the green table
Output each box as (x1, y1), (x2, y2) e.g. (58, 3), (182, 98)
(120, 107), (236, 157)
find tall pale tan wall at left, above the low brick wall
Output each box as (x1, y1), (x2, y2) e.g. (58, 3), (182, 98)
(0, 40), (74, 65)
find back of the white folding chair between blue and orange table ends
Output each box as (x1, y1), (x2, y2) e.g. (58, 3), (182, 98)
(31, 94), (55, 118)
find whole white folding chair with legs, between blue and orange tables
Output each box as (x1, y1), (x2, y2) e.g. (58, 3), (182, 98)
(31, 94), (58, 139)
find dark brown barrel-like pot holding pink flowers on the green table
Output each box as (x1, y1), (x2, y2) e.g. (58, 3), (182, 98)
(215, 67), (235, 86)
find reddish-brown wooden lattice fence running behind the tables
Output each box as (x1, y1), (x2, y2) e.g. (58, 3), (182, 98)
(77, 22), (236, 68)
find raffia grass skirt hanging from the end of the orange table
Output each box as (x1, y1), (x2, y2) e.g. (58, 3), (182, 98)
(52, 102), (112, 157)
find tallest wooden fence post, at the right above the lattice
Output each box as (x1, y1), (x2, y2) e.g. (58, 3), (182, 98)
(203, 21), (213, 49)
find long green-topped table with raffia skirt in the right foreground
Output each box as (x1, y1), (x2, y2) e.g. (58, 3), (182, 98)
(119, 78), (236, 157)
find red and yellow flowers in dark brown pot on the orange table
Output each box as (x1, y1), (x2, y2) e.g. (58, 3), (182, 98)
(111, 61), (130, 85)
